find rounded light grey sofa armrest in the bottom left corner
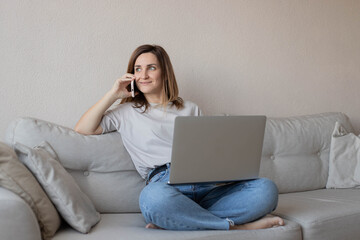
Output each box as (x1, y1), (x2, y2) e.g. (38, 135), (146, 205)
(0, 187), (41, 240)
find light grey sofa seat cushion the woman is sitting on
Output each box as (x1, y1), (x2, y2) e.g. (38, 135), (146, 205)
(53, 213), (301, 240)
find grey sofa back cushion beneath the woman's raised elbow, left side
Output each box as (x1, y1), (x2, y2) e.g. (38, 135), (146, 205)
(5, 117), (145, 213)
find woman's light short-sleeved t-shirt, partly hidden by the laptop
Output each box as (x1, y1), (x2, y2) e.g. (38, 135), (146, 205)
(100, 101), (202, 179)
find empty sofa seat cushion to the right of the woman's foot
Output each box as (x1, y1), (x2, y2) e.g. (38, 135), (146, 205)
(275, 189), (360, 239)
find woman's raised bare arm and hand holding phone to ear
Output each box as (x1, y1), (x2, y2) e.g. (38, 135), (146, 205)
(74, 73), (135, 135)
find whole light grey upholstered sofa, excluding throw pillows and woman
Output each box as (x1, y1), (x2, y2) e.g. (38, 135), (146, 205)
(0, 113), (360, 240)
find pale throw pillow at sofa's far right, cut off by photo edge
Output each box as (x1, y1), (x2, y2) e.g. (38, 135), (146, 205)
(326, 122), (360, 188)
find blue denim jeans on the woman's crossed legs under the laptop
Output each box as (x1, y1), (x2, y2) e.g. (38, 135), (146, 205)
(139, 168), (278, 230)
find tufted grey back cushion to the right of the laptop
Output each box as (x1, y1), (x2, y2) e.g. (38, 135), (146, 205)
(260, 113), (353, 193)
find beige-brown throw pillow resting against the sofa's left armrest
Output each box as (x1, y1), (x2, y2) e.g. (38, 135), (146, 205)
(0, 142), (61, 239)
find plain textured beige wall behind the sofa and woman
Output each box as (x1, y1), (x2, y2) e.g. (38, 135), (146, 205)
(0, 0), (360, 140)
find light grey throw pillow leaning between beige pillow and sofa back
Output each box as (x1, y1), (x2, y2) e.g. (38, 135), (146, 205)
(15, 142), (100, 233)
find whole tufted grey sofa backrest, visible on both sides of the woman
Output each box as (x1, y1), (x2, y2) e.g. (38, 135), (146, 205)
(5, 113), (352, 213)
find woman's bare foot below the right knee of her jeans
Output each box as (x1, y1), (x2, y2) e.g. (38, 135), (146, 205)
(230, 216), (284, 230)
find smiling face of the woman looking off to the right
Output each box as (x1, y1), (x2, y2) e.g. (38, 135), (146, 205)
(134, 53), (162, 103)
